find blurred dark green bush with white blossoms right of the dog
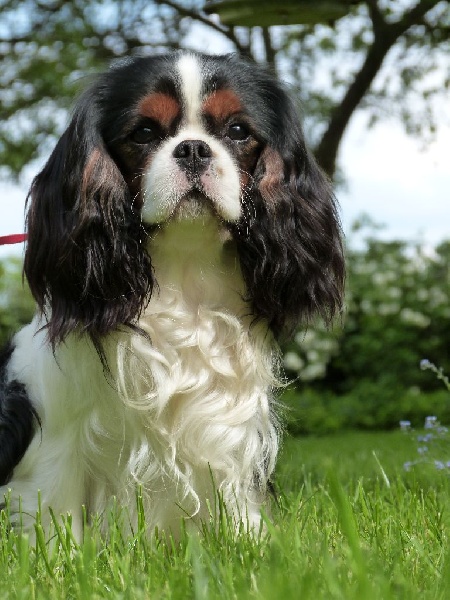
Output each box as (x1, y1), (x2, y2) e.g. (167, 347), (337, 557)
(285, 229), (450, 433)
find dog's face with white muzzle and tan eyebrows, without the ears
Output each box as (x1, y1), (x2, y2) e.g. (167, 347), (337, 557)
(105, 55), (261, 224)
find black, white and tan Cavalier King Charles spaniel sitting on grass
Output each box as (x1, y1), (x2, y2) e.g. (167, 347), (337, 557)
(0, 52), (344, 538)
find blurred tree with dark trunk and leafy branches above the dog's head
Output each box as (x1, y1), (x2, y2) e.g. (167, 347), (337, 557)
(0, 0), (450, 176)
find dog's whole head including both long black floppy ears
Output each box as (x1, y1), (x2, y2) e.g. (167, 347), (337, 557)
(25, 53), (344, 344)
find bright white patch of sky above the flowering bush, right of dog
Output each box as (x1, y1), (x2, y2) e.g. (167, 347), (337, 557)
(338, 112), (450, 244)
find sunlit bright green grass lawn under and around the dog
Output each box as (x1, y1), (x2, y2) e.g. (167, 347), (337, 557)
(0, 433), (450, 600)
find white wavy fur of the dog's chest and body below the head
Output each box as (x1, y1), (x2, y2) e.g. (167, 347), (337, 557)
(1, 215), (278, 536)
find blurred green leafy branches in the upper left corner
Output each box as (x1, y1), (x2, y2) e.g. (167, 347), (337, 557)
(0, 0), (190, 176)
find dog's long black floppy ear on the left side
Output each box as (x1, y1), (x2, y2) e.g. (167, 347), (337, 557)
(24, 91), (153, 348)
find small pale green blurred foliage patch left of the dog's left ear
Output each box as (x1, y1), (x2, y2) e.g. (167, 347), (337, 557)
(0, 257), (35, 347)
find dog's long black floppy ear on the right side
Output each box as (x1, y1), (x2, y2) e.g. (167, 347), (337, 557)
(235, 129), (345, 337)
